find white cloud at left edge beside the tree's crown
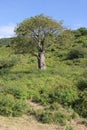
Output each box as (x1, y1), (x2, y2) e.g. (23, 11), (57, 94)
(0, 24), (15, 38)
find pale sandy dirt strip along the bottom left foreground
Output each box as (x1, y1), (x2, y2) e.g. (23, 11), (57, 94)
(0, 116), (62, 130)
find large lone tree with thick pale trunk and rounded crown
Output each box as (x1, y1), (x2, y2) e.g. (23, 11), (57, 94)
(15, 15), (63, 69)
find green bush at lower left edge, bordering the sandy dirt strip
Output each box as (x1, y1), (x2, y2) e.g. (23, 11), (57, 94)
(0, 94), (28, 116)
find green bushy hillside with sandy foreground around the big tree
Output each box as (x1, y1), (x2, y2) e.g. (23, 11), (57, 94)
(0, 27), (87, 130)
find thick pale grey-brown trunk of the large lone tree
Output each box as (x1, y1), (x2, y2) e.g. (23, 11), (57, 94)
(38, 51), (46, 70)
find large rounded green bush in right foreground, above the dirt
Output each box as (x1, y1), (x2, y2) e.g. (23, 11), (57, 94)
(49, 85), (77, 106)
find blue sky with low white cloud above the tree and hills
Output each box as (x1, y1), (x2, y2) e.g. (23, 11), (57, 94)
(0, 0), (87, 38)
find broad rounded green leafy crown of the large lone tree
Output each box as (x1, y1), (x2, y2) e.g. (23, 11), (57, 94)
(15, 14), (63, 50)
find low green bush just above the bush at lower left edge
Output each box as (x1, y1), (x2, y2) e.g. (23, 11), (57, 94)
(5, 86), (28, 99)
